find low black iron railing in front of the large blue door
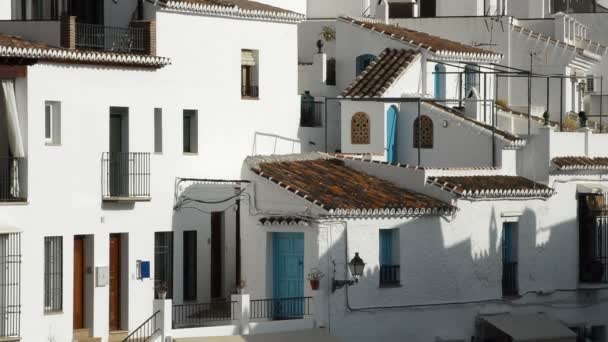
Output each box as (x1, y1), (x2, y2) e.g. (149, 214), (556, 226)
(249, 297), (312, 319)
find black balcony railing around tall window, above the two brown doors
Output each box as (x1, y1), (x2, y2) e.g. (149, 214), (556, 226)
(101, 152), (150, 201)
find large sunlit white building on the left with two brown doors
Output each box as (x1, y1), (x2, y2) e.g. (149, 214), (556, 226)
(0, 0), (302, 341)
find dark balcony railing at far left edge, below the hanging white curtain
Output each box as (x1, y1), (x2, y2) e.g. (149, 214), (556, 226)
(0, 157), (27, 202)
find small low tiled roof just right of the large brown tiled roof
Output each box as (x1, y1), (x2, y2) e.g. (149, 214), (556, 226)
(427, 176), (555, 198)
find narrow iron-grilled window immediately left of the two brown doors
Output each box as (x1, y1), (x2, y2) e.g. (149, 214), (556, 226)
(44, 236), (63, 312)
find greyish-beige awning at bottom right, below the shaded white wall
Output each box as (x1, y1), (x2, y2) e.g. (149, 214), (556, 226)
(481, 314), (576, 342)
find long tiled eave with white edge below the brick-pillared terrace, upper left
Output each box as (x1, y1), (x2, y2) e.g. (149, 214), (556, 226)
(0, 34), (170, 68)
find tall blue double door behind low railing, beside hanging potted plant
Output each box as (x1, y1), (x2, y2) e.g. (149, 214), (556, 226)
(272, 233), (304, 318)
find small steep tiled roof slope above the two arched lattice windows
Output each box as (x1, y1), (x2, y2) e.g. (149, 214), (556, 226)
(342, 49), (420, 98)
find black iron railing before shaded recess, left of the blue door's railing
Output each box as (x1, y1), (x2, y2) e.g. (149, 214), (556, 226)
(172, 302), (236, 329)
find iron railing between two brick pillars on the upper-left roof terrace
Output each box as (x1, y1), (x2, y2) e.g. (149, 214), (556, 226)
(76, 23), (146, 54)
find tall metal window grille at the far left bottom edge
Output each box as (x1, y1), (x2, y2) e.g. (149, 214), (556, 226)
(0, 233), (21, 337)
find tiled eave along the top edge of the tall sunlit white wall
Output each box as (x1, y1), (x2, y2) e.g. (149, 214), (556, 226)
(160, 0), (305, 22)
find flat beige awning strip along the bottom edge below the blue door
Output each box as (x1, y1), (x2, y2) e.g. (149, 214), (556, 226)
(174, 329), (340, 342)
